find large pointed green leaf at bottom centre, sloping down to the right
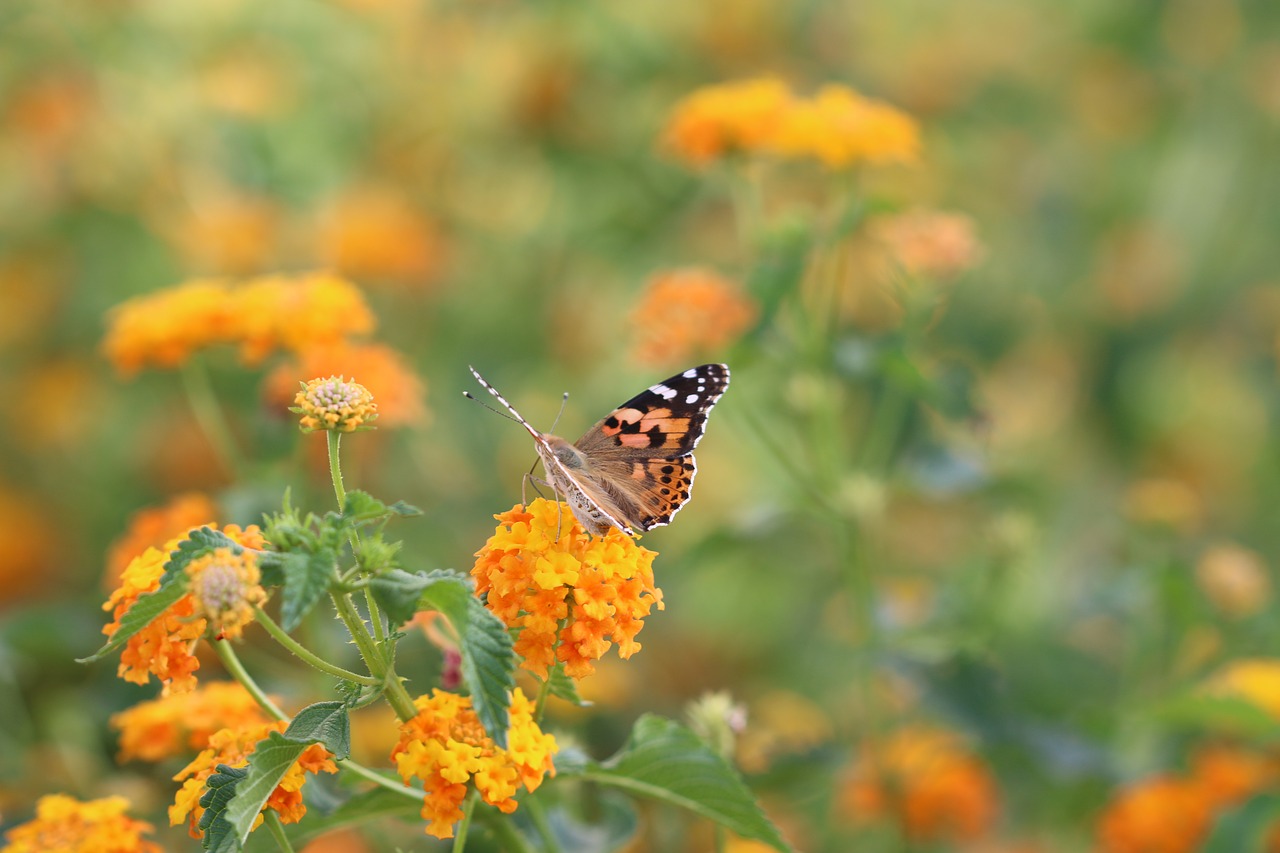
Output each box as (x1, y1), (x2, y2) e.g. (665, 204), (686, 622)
(573, 715), (791, 850)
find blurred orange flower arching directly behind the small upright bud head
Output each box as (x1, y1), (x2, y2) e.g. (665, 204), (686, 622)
(262, 343), (426, 428)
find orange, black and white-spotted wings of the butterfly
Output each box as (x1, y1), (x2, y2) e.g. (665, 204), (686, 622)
(575, 364), (728, 530)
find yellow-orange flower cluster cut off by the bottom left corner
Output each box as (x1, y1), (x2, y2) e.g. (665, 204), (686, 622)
(0, 794), (160, 853)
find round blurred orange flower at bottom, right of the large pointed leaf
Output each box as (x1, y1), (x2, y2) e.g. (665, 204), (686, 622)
(838, 726), (998, 841)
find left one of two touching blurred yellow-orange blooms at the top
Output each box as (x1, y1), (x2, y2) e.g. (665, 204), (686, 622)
(663, 77), (794, 165)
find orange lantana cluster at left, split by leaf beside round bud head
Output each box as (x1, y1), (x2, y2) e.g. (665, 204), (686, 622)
(102, 524), (265, 695)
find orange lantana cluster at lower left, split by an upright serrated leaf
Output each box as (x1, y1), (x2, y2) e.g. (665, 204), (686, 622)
(169, 720), (338, 838)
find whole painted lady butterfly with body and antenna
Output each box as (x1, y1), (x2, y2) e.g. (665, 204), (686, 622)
(467, 364), (728, 537)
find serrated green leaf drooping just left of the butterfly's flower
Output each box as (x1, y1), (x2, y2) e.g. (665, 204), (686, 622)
(369, 569), (516, 747)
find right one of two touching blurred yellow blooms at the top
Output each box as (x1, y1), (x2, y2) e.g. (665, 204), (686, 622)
(764, 85), (920, 169)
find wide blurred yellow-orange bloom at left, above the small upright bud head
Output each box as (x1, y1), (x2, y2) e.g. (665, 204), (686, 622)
(102, 273), (374, 375)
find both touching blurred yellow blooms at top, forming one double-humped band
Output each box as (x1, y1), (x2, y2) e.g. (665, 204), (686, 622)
(664, 78), (920, 169)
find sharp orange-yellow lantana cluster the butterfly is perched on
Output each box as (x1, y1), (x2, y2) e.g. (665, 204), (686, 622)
(471, 498), (663, 679)
